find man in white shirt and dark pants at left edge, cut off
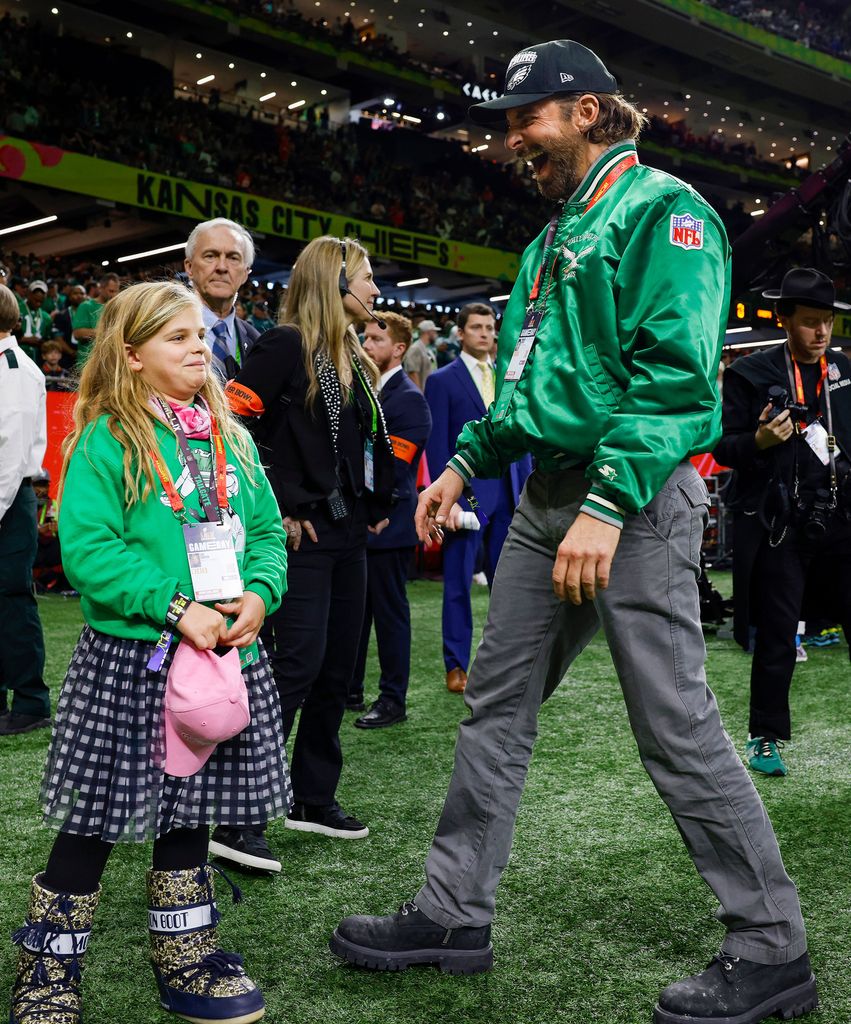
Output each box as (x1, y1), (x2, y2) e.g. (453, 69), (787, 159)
(0, 285), (50, 736)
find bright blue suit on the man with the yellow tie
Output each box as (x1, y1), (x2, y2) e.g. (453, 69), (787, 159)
(425, 357), (531, 672)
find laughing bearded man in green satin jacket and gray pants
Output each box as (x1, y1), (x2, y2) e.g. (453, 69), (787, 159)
(331, 40), (817, 1024)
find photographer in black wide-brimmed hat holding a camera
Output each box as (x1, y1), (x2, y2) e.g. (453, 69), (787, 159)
(714, 267), (851, 775)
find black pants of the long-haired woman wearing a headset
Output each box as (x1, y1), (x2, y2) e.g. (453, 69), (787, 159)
(261, 502), (367, 806)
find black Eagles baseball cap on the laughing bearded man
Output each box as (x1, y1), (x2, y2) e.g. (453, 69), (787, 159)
(467, 39), (618, 125)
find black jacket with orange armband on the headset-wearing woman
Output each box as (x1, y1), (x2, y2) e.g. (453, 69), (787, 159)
(227, 327), (394, 523)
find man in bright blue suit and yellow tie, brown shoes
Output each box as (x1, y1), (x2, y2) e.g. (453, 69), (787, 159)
(425, 302), (531, 693)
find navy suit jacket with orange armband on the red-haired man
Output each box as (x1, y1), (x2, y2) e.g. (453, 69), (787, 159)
(368, 370), (431, 549)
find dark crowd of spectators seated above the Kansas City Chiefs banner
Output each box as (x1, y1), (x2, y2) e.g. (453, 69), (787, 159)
(0, 16), (798, 258)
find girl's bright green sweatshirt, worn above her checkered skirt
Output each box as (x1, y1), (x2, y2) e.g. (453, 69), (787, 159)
(59, 416), (287, 663)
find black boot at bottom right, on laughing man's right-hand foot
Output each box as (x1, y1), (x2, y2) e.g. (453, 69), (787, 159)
(653, 953), (818, 1024)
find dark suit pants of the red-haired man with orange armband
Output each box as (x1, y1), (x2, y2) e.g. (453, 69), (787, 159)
(350, 548), (414, 707)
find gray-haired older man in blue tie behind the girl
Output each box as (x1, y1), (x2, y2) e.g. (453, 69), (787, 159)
(183, 217), (260, 384)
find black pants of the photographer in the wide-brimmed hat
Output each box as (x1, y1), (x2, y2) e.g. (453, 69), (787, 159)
(750, 521), (851, 739)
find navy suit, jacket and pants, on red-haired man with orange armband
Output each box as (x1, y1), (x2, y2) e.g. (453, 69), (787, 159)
(349, 370), (431, 708)
